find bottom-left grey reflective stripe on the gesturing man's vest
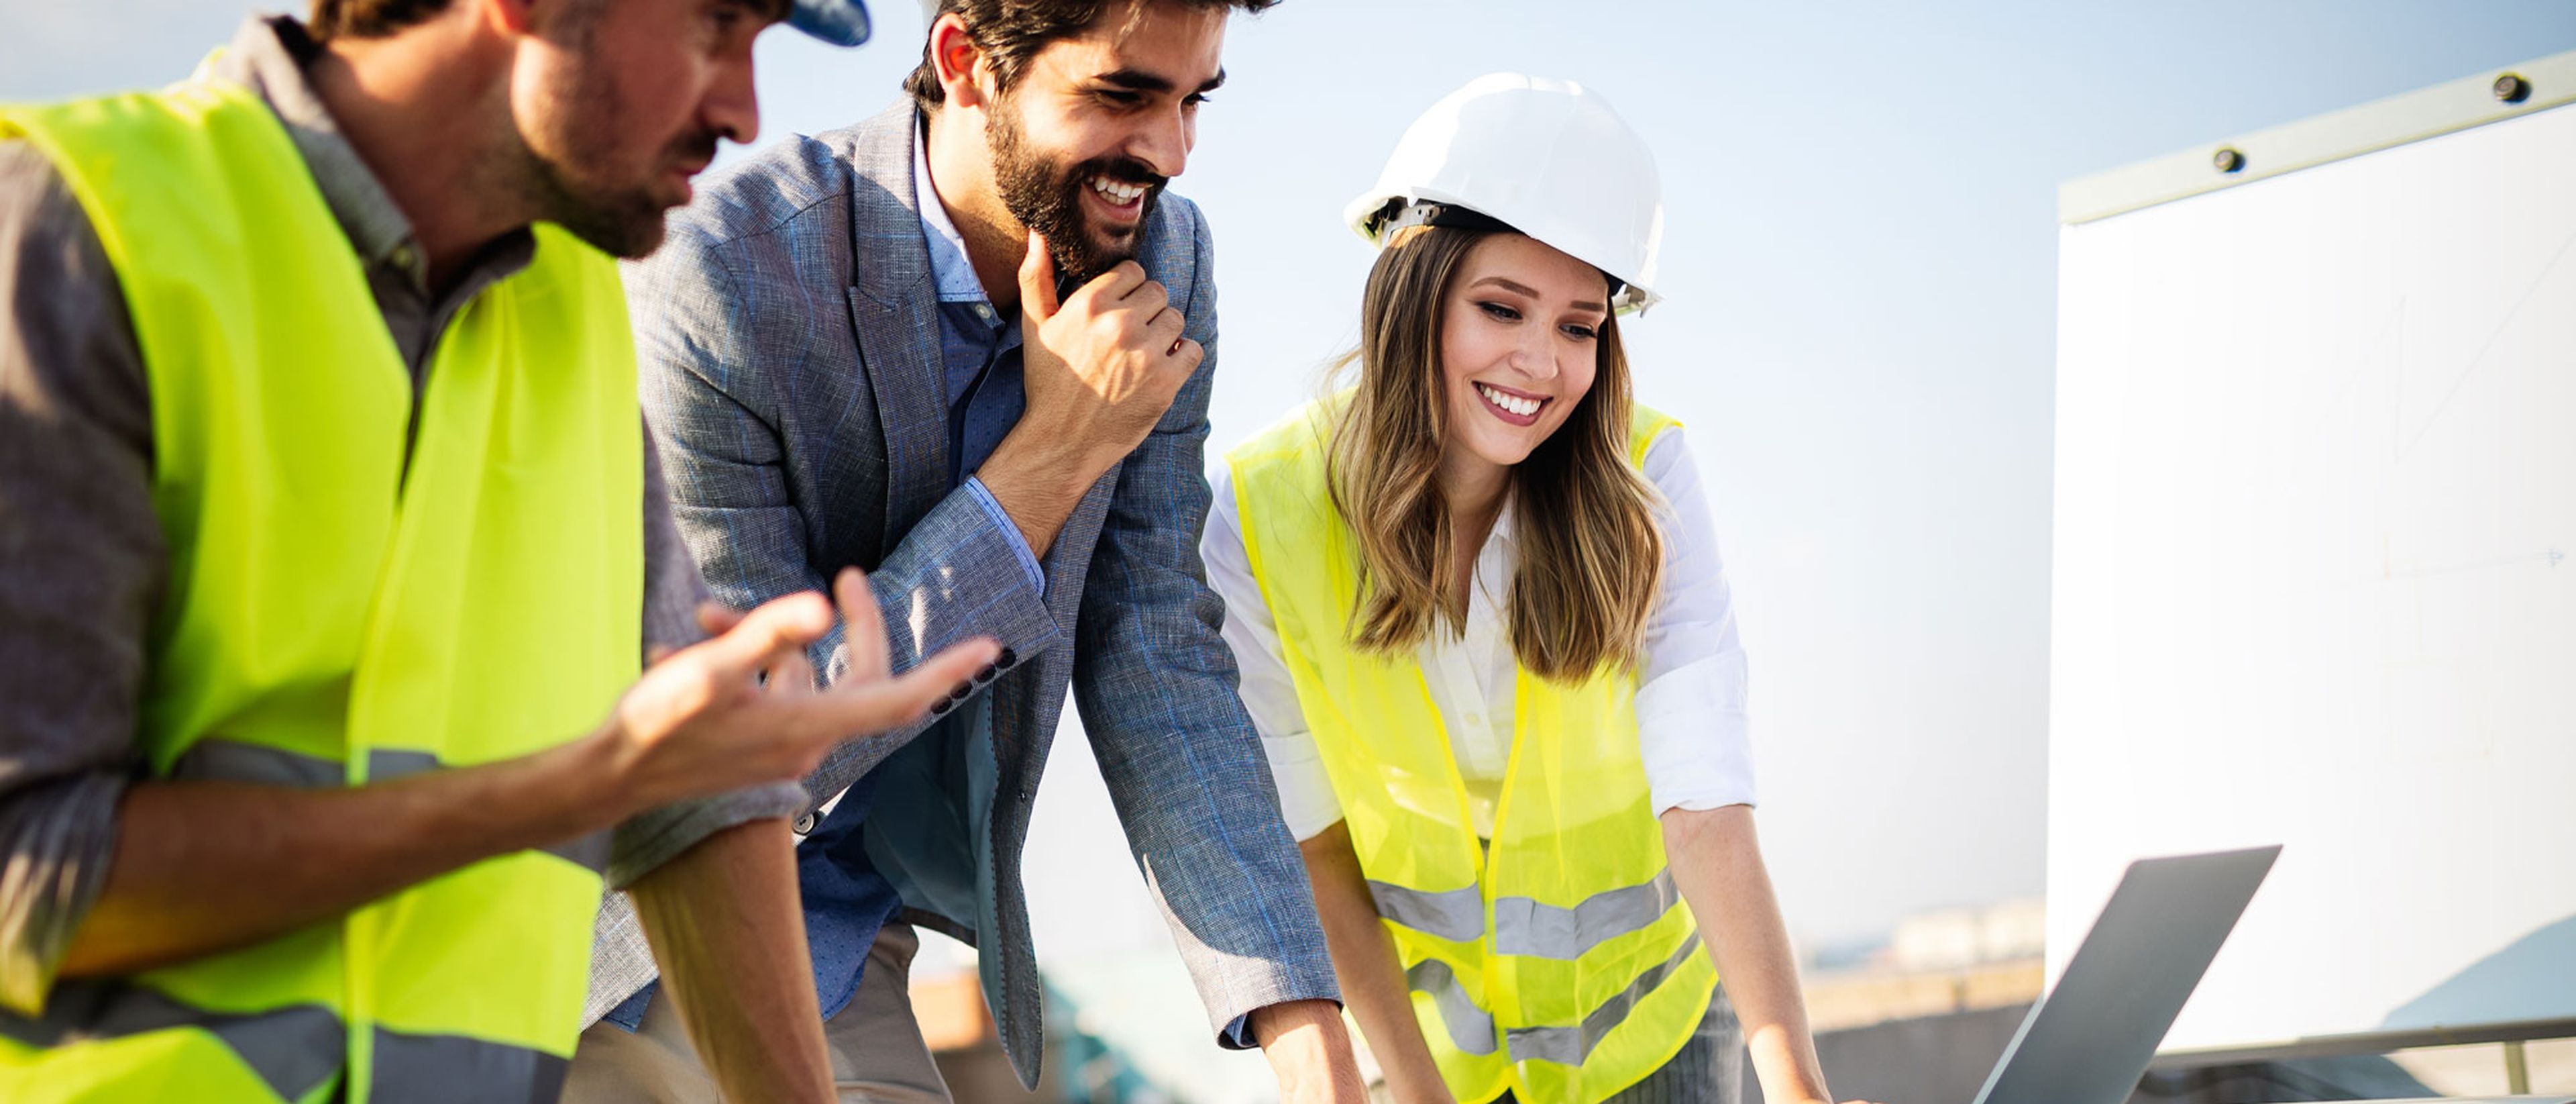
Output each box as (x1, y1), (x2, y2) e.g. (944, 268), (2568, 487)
(0, 978), (347, 1099)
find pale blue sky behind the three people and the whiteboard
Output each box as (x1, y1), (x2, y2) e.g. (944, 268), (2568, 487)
(0, 0), (2576, 947)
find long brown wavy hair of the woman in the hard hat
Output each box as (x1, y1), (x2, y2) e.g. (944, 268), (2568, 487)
(1327, 227), (1664, 684)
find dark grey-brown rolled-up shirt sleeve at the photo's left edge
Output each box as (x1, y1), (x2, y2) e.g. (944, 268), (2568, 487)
(0, 142), (168, 1013)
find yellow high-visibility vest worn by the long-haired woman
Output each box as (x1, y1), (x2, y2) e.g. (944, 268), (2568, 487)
(1226, 400), (1718, 1104)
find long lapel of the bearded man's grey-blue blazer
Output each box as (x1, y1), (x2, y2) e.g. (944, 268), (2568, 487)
(850, 101), (948, 550)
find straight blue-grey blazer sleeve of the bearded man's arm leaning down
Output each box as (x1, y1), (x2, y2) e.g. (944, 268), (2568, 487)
(1074, 199), (1340, 1047)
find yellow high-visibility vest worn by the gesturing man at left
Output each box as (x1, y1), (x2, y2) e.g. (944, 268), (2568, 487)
(0, 77), (644, 1104)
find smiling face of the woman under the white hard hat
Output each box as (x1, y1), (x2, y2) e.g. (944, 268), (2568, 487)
(1440, 235), (1610, 467)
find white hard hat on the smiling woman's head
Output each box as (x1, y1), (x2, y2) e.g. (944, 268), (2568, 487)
(1342, 72), (1664, 312)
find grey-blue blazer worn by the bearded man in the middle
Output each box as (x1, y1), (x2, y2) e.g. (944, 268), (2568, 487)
(592, 101), (1337, 1083)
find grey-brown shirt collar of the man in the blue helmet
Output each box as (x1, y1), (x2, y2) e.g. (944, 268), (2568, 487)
(209, 15), (536, 289)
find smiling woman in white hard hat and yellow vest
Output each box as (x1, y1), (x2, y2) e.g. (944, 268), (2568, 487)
(1205, 74), (1865, 1104)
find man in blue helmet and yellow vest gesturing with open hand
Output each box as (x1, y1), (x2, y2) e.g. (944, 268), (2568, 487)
(0, 0), (994, 1104)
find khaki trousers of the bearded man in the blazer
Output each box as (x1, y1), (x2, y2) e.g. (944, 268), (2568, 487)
(564, 923), (948, 1104)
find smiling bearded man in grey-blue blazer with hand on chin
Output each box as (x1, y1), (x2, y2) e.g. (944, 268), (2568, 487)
(567, 0), (1360, 1101)
